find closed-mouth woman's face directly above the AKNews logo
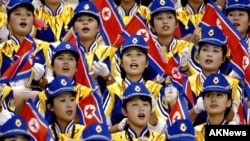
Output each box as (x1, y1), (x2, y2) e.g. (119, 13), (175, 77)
(203, 92), (231, 115)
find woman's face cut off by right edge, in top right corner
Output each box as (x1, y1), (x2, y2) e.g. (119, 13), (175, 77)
(227, 10), (250, 37)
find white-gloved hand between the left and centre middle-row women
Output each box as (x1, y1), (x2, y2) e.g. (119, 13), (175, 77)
(92, 61), (109, 77)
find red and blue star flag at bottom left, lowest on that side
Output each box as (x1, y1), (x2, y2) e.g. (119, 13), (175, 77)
(20, 99), (53, 141)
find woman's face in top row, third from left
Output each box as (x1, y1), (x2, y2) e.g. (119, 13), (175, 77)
(152, 12), (177, 37)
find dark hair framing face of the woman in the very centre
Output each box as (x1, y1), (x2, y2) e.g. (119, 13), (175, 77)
(120, 47), (150, 81)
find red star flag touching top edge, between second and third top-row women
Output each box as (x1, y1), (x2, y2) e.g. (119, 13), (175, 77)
(94, 0), (125, 47)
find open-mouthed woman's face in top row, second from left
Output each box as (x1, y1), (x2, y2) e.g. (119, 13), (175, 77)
(74, 15), (100, 41)
